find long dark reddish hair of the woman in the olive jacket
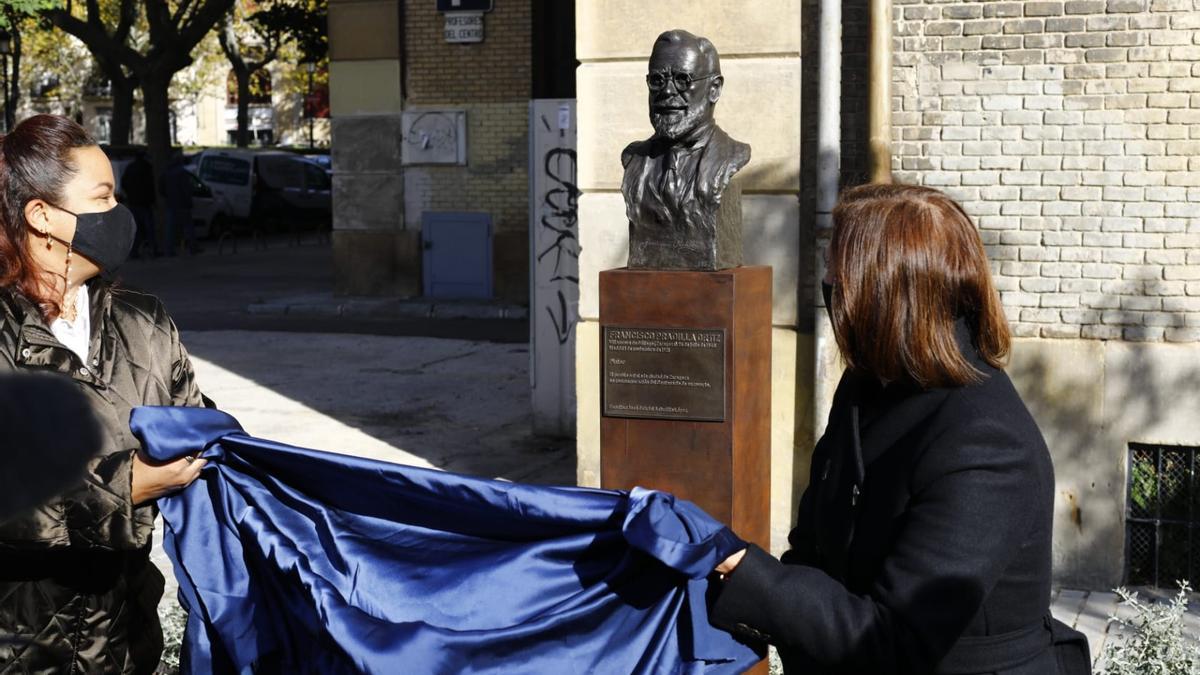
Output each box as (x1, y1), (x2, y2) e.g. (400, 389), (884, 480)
(0, 115), (96, 318)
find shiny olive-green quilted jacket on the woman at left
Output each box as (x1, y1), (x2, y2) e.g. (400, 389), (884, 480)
(0, 280), (211, 675)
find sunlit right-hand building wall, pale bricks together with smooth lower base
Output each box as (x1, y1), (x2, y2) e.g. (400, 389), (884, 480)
(883, 0), (1200, 587)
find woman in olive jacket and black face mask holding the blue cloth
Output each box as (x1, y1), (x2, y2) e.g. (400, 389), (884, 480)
(0, 115), (211, 674)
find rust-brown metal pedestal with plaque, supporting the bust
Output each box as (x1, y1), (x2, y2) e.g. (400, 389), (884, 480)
(600, 267), (772, 673)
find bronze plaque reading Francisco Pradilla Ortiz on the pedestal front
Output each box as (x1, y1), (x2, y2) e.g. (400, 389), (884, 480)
(600, 325), (726, 422)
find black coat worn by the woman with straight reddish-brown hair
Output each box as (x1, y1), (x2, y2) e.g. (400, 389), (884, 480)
(712, 325), (1056, 675)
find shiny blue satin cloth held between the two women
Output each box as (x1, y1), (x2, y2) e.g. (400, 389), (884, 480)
(131, 407), (761, 675)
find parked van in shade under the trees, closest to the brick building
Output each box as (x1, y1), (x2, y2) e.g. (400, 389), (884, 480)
(193, 148), (332, 229)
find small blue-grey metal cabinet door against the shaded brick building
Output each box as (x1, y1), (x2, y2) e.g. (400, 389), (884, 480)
(421, 211), (492, 298)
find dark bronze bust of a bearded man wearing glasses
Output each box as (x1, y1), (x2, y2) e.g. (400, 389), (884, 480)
(620, 30), (750, 270)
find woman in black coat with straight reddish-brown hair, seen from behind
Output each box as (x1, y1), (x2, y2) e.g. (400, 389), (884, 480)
(712, 185), (1090, 675)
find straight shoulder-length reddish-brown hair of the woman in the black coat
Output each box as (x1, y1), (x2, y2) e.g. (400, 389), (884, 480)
(829, 185), (1010, 387)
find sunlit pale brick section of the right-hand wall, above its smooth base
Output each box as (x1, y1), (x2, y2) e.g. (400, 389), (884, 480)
(893, 0), (1200, 342)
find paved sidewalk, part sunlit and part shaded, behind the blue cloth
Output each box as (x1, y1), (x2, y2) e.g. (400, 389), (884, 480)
(184, 330), (575, 483)
